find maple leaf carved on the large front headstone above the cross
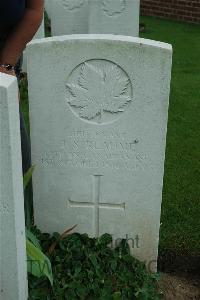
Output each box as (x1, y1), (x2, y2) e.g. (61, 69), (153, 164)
(66, 62), (131, 121)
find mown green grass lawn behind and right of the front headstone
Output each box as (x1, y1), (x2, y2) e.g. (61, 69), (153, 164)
(22, 17), (200, 255)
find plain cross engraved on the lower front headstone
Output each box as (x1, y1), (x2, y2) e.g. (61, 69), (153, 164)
(68, 175), (125, 237)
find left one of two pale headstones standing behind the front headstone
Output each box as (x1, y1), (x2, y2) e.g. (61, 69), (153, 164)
(51, 0), (89, 36)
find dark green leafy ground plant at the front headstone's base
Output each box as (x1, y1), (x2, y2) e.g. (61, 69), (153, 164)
(29, 228), (162, 300)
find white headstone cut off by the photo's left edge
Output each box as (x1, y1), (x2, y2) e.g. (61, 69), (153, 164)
(0, 73), (27, 300)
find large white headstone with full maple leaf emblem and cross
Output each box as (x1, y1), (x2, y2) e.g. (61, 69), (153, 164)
(28, 35), (172, 270)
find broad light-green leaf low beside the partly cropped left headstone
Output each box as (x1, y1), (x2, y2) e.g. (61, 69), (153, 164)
(26, 240), (53, 285)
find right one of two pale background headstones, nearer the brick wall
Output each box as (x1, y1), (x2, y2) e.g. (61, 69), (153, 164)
(89, 0), (140, 36)
